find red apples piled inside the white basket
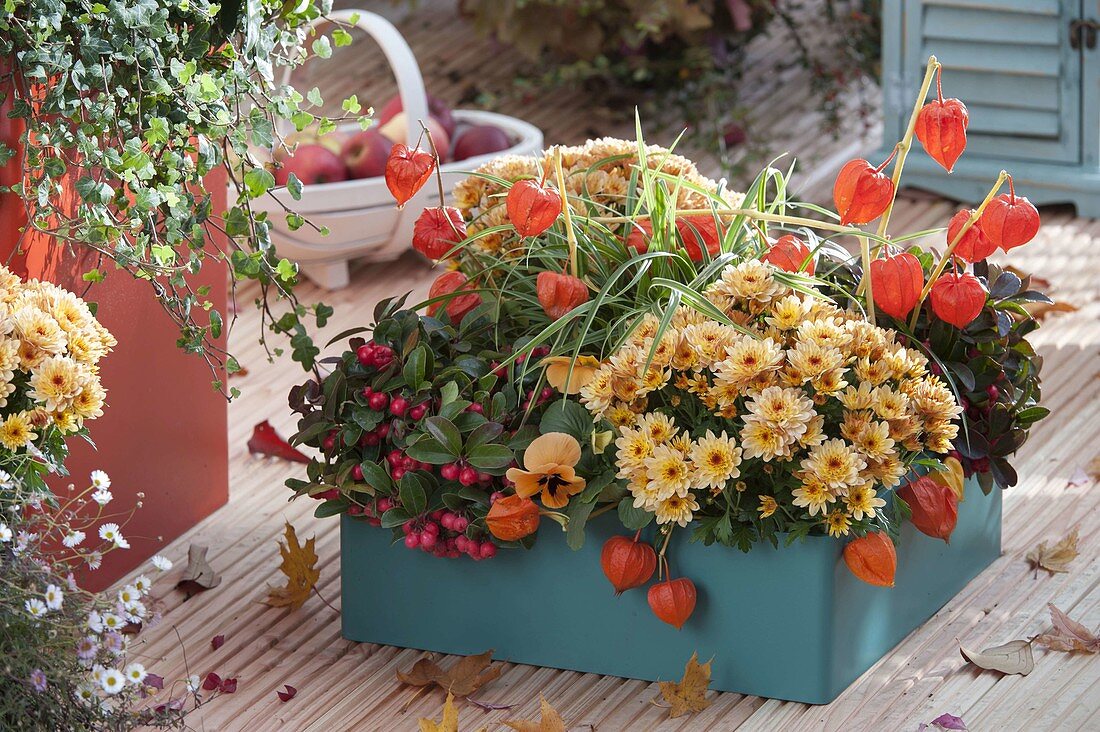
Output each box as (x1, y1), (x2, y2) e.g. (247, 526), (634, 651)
(274, 95), (512, 185)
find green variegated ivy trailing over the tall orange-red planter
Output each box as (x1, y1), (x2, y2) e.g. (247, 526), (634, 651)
(0, 0), (369, 396)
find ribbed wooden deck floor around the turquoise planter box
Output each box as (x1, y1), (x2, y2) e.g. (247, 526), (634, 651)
(124, 2), (1100, 732)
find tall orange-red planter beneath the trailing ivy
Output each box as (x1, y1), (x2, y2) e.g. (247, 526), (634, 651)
(0, 82), (229, 589)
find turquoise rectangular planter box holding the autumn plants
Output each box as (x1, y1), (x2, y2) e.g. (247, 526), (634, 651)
(341, 481), (1001, 704)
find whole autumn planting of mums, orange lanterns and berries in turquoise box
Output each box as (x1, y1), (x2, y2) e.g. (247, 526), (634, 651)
(288, 58), (1046, 627)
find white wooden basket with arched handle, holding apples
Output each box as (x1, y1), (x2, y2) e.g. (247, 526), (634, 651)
(253, 10), (542, 289)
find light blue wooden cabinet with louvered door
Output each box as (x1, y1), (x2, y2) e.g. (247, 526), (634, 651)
(879, 0), (1100, 217)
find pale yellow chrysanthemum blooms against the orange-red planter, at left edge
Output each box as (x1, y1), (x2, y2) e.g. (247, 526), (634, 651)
(0, 265), (116, 499)
